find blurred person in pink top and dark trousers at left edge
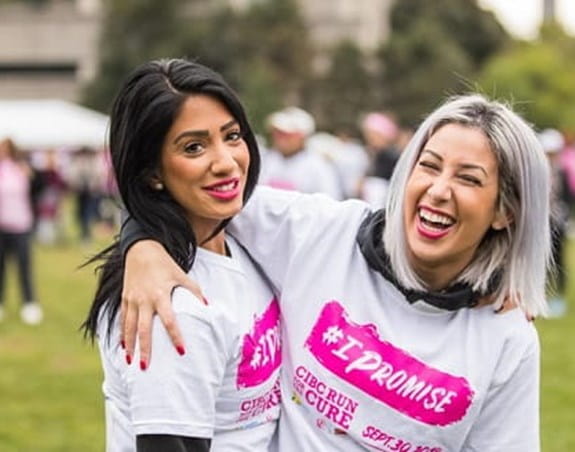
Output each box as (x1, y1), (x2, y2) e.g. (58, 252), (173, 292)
(0, 138), (43, 325)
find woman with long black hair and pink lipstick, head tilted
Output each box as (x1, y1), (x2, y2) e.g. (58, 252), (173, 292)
(83, 60), (281, 452)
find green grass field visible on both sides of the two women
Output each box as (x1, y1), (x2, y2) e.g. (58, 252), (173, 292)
(0, 216), (575, 452)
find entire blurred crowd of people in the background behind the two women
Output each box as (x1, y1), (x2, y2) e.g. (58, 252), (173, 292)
(0, 103), (575, 324)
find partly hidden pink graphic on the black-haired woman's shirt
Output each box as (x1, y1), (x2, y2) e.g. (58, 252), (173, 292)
(236, 298), (281, 388)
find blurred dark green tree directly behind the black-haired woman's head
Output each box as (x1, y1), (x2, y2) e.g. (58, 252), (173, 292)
(85, 0), (311, 134)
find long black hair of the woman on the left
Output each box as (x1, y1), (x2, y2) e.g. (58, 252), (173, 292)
(81, 59), (260, 341)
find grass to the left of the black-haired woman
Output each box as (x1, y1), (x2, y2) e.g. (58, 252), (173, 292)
(0, 233), (104, 452)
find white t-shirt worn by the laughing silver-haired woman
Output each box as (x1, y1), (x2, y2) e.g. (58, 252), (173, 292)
(228, 188), (540, 452)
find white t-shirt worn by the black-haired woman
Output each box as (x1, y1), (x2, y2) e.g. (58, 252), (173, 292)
(99, 237), (281, 452)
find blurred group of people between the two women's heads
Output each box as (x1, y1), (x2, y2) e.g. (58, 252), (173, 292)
(260, 107), (410, 207)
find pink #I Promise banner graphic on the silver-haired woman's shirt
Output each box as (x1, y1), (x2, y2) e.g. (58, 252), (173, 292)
(306, 301), (473, 425)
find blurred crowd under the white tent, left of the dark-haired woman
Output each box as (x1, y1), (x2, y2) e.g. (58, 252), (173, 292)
(0, 138), (119, 325)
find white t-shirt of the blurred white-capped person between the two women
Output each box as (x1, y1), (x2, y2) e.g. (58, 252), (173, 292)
(260, 149), (345, 199)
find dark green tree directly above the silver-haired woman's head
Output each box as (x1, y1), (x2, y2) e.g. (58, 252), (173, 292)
(379, 0), (509, 125)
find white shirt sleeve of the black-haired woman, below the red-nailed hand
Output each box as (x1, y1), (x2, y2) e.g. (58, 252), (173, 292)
(126, 288), (234, 438)
